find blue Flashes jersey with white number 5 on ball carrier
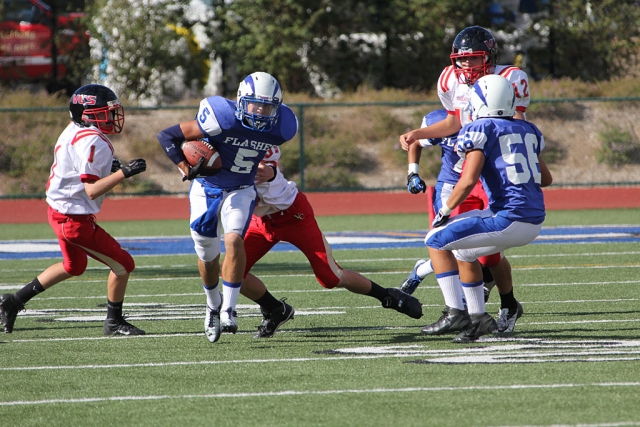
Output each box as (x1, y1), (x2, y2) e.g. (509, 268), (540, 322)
(196, 96), (298, 188)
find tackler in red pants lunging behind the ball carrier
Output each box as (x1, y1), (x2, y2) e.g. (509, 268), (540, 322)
(240, 147), (422, 338)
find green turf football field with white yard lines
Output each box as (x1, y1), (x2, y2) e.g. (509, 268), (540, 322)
(0, 210), (640, 427)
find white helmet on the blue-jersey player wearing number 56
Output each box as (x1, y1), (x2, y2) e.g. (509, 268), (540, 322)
(469, 74), (516, 120)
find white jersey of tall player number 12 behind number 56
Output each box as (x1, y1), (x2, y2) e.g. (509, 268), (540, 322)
(438, 65), (531, 126)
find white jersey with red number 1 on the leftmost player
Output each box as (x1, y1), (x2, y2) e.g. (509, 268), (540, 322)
(47, 122), (113, 215)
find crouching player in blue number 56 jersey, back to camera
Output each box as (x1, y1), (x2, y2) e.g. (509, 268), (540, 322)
(425, 74), (553, 343)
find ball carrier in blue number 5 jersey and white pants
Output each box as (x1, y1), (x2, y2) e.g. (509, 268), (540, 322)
(158, 72), (298, 342)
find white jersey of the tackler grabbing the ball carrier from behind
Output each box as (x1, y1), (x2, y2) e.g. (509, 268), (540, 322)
(253, 146), (298, 216)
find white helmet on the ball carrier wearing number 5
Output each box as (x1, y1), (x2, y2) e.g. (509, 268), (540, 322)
(236, 71), (282, 132)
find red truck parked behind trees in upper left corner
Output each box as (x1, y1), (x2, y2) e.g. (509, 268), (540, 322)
(0, 0), (88, 88)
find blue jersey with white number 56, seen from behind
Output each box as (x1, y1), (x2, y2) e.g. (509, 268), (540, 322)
(457, 118), (545, 224)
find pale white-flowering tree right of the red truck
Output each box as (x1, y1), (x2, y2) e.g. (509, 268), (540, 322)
(88, 0), (208, 104)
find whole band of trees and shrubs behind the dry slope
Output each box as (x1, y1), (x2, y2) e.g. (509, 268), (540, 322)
(23, 0), (640, 99)
